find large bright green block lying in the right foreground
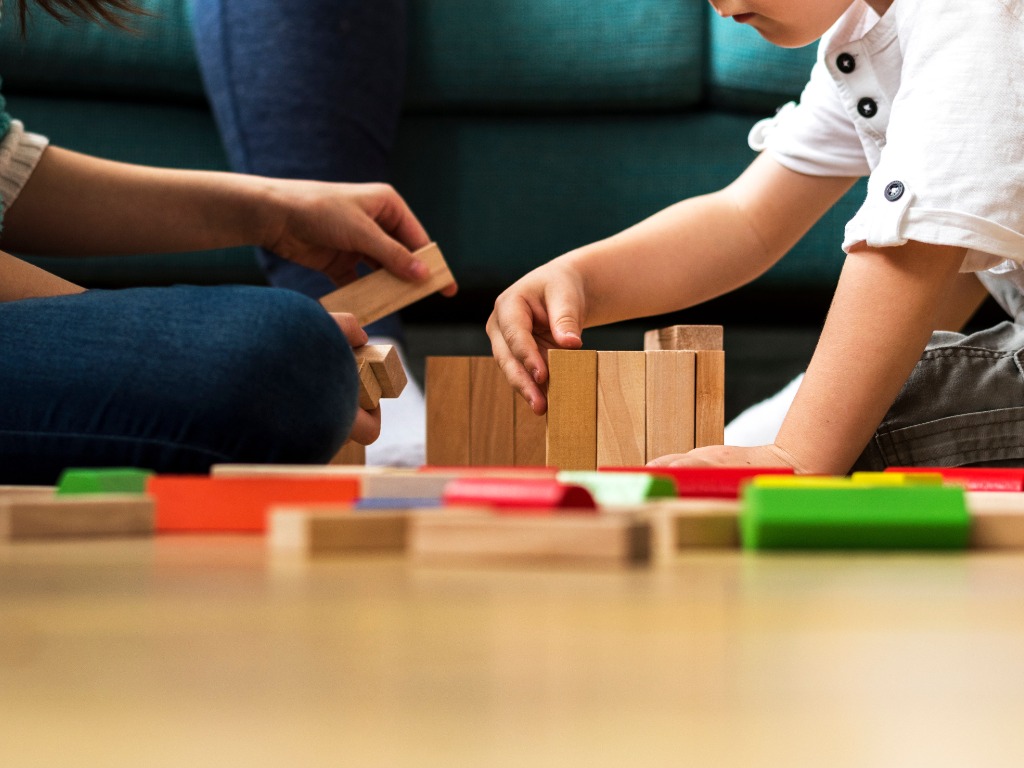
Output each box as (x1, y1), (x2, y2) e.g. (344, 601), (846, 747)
(739, 483), (971, 550)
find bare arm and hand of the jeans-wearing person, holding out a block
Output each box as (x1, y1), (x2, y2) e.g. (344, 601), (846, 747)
(0, 146), (442, 283)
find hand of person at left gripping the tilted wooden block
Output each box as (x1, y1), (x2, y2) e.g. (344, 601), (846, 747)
(261, 180), (455, 296)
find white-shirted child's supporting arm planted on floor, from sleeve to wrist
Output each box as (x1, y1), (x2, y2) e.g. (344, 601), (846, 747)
(775, 243), (964, 473)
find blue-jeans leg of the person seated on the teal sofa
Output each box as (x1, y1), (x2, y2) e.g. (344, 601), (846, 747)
(193, 0), (407, 338)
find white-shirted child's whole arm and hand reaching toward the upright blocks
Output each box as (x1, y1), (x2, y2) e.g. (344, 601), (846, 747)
(487, 154), (854, 413)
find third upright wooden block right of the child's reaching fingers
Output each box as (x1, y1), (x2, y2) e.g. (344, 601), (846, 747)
(645, 350), (696, 461)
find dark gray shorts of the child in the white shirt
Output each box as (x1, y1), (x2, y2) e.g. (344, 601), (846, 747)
(854, 273), (1024, 470)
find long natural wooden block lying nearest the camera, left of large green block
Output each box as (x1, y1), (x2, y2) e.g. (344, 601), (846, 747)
(408, 512), (650, 566)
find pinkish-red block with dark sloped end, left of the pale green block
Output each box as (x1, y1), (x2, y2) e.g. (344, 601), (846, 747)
(443, 477), (597, 511)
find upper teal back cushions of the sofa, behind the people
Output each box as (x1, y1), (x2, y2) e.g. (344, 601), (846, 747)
(0, 0), (813, 113)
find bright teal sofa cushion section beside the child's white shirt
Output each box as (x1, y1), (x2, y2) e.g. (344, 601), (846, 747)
(708, 13), (816, 114)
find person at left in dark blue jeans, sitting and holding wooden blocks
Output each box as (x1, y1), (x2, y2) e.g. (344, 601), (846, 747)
(0, 0), (448, 483)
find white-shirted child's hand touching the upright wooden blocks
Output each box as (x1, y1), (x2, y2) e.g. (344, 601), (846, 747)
(486, 260), (586, 415)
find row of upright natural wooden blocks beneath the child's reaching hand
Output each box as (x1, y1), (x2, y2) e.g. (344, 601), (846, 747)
(426, 326), (725, 470)
